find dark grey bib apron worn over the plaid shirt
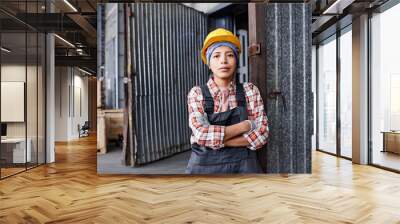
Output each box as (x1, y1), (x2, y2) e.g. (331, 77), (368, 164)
(185, 83), (262, 174)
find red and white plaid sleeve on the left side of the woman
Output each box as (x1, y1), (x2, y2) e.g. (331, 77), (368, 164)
(188, 86), (225, 150)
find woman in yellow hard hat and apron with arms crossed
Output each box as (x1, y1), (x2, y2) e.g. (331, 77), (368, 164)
(186, 28), (268, 174)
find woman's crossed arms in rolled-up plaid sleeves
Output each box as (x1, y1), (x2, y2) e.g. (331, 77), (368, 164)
(188, 84), (269, 150)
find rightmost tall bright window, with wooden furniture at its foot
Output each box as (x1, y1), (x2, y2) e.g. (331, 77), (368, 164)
(370, 4), (400, 170)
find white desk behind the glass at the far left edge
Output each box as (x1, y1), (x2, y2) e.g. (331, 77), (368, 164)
(1, 138), (32, 163)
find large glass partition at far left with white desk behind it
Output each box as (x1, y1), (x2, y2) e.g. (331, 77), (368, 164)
(0, 1), (46, 178)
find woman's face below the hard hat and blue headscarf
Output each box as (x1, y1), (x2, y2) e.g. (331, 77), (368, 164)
(209, 46), (236, 79)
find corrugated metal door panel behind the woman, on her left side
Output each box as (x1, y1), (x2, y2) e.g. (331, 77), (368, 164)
(132, 3), (208, 165)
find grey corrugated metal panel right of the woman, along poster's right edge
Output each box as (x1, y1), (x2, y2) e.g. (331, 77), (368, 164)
(265, 3), (313, 173)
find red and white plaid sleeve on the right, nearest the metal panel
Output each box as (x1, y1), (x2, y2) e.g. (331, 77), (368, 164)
(243, 83), (269, 150)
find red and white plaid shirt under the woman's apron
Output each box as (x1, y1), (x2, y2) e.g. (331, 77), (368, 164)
(188, 77), (269, 150)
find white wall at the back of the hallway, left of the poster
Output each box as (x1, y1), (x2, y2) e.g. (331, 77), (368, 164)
(55, 67), (88, 141)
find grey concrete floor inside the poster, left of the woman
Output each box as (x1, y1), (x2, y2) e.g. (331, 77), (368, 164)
(97, 148), (191, 174)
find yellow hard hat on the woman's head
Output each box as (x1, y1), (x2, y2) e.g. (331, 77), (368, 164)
(201, 28), (241, 64)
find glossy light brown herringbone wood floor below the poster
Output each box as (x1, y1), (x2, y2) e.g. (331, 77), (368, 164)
(0, 134), (400, 224)
